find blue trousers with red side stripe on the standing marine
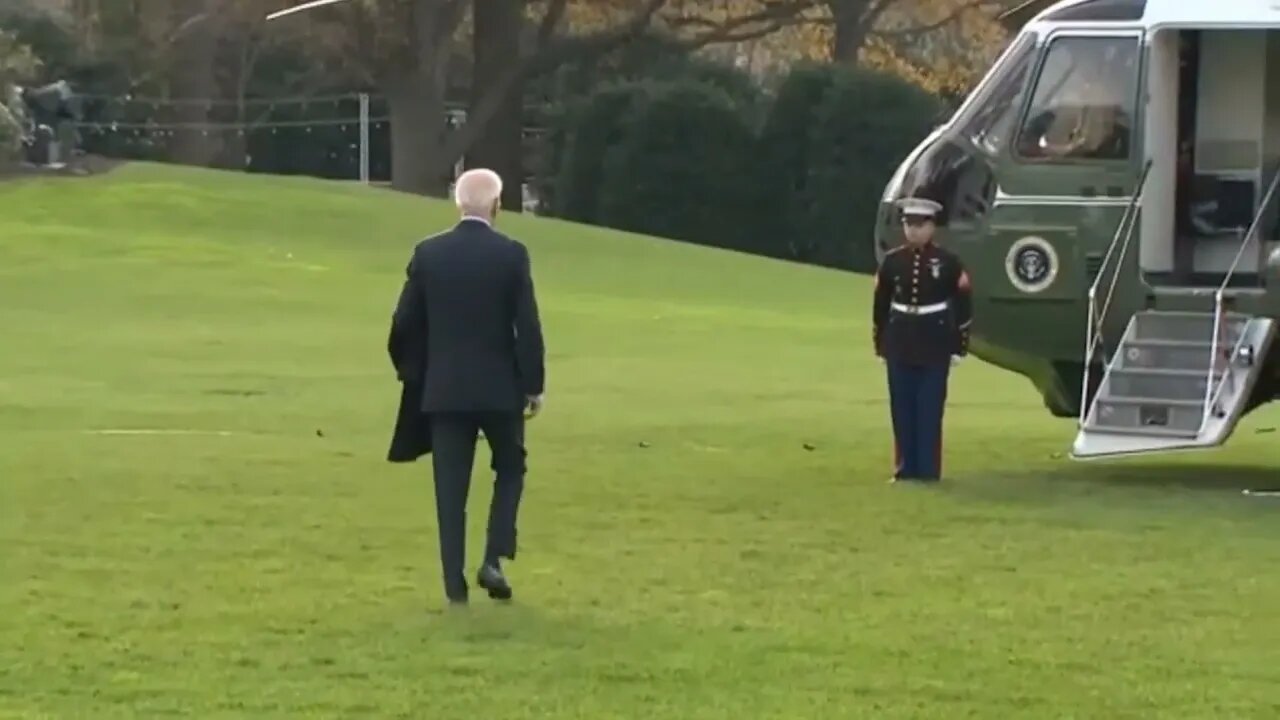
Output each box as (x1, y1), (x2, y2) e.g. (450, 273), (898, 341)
(886, 360), (951, 480)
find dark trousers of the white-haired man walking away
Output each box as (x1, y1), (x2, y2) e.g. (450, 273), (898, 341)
(431, 413), (525, 598)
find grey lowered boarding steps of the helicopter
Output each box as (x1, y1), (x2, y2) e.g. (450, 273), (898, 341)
(1071, 310), (1276, 460)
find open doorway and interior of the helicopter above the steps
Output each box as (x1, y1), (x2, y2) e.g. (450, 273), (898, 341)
(1139, 29), (1280, 288)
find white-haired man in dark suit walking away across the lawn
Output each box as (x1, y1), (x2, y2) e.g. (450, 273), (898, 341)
(389, 169), (545, 603)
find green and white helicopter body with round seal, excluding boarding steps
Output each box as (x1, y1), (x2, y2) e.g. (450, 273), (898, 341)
(876, 0), (1280, 416)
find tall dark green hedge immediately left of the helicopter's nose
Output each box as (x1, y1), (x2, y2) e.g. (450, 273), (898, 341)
(792, 68), (941, 272)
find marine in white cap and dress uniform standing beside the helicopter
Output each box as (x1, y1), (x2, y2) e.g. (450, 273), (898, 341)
(872, 197), (973, 482)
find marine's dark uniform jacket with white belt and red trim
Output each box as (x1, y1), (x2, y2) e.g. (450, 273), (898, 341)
(872, 242), (973, 365)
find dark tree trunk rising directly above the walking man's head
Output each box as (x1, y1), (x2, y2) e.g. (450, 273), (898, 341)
(466, 0), (525, 213)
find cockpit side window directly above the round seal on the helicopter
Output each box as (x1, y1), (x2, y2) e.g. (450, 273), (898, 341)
(1016, 36), (1138, 160)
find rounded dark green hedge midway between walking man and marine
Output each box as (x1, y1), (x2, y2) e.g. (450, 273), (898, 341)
(600, 79), (759, 249)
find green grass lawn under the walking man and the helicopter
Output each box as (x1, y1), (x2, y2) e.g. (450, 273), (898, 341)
(0, 165), (1280, 720)
